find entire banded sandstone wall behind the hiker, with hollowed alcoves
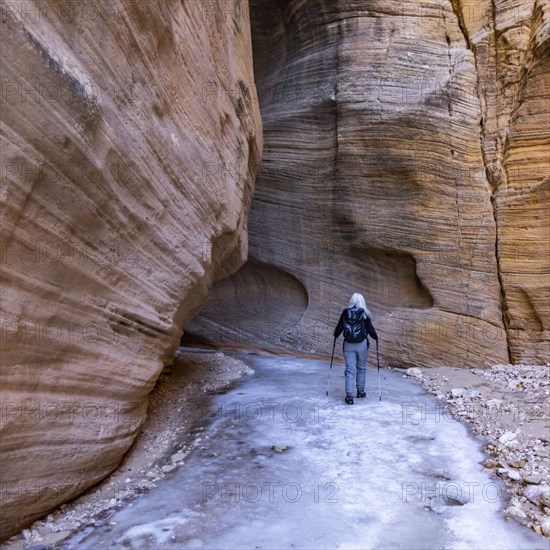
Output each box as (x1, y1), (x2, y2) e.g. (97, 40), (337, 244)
(187, 0), (550, 366)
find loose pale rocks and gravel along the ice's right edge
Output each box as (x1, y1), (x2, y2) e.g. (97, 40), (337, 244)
(406, 365), (550, 537)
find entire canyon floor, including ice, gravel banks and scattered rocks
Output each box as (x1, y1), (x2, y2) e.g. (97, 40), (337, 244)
(2, 348), (550, 550)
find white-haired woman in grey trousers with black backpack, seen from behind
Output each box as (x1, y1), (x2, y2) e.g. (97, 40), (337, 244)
(334, 292), (378, 405)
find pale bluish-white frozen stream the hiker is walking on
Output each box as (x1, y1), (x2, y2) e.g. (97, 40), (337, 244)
(65, 355), (548, 550)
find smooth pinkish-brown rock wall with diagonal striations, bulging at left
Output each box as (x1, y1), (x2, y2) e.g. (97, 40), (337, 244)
(0, 0), (261, 537)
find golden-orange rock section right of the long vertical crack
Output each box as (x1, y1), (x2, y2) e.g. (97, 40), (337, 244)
(453, 0), (550, 363)
